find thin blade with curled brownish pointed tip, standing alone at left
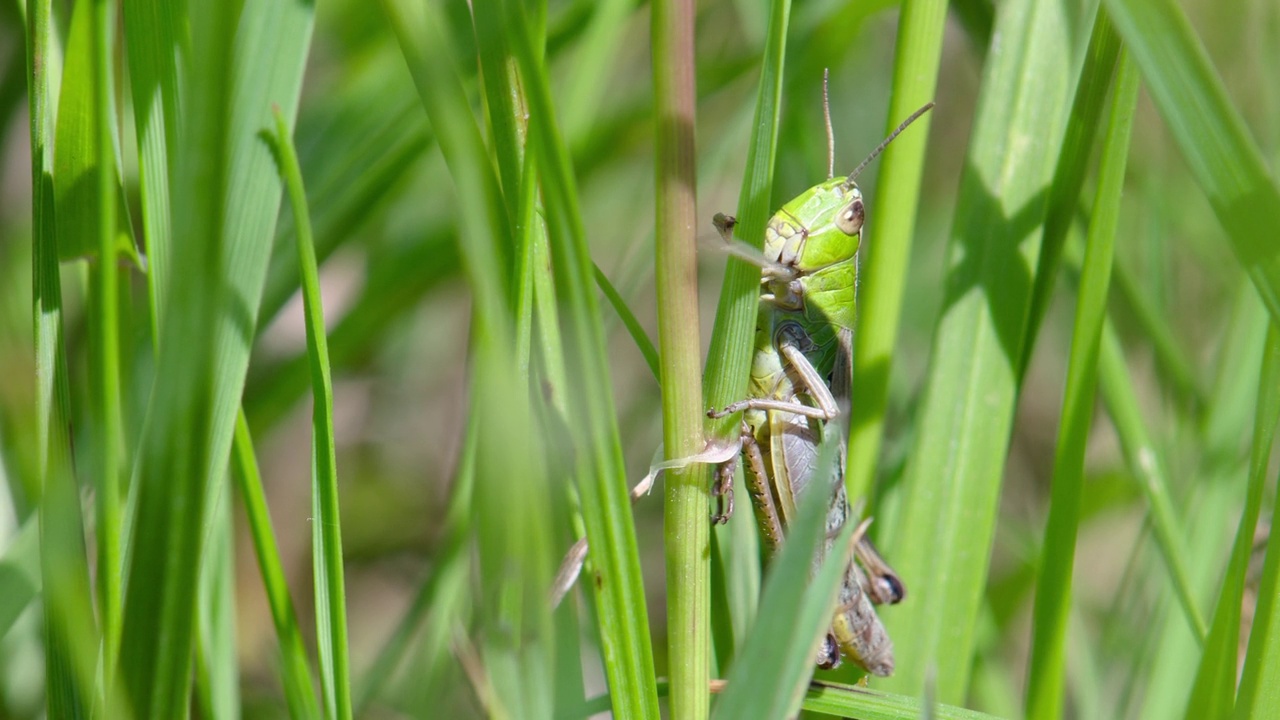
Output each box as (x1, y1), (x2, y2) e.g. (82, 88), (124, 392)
(274, 108), (352, 720)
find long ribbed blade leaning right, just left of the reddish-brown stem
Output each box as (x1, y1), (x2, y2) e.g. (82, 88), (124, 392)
(502, 3), (658, 717)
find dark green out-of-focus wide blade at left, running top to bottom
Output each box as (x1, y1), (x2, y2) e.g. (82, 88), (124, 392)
(120, 1), (234, 717)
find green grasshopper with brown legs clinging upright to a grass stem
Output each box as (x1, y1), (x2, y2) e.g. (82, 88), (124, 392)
(708, 102), (933, 676)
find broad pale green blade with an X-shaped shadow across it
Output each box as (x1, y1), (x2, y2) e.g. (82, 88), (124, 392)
(884, 0), (1078, 703)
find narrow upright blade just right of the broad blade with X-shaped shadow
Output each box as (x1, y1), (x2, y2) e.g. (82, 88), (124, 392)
(1027, 49), (1139, 720)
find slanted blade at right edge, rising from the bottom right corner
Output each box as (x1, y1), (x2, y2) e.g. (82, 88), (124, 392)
(1187, 322), (1280, 717)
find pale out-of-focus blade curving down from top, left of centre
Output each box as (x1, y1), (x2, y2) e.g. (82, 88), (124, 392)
(384, 1), (554, 717)
